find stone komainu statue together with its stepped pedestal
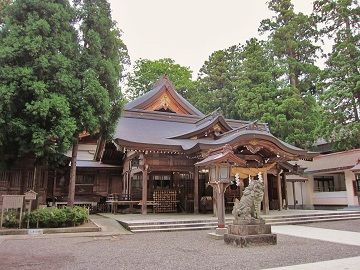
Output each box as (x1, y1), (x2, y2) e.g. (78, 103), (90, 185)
(224, 173), (277, 247)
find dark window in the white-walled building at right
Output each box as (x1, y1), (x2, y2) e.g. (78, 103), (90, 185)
(314, 174), (346, 192)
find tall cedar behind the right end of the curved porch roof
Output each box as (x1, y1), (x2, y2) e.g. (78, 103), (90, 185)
(259, 0), (319, 147)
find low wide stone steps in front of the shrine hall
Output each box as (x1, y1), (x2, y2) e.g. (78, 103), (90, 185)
(103, 210), (360, 233)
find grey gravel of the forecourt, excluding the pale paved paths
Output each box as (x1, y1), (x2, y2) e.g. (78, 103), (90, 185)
(0, 231), (360, 270)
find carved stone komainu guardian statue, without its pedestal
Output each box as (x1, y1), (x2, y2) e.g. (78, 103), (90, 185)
(232, 179), (264, 221)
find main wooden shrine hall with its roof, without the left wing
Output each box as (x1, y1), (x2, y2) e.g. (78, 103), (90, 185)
(98, 76), (316, 214)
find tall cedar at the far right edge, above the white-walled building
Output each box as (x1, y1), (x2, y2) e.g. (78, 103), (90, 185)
(314, 0), (360, 150)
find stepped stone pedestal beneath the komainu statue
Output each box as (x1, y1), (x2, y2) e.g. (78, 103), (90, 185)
(224, 219), (277, 247)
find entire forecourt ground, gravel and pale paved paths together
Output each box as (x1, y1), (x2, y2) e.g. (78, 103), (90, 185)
(0, 215), (360, 270)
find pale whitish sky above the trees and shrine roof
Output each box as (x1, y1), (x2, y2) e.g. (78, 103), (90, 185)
(109, 0), (312, 77)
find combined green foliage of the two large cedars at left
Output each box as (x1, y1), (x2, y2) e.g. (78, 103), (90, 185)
(0, 0), (128, 169)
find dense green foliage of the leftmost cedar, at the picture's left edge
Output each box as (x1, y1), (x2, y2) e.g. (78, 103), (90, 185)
(0, 0), (80, 169)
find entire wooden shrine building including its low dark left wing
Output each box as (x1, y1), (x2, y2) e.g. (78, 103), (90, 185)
(0, 76), (317, 214)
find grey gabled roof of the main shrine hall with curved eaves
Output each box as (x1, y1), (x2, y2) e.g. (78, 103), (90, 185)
(114, 77), (316, 158)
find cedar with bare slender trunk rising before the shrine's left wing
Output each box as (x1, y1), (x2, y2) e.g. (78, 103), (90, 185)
(68, 0), (129, 205)
